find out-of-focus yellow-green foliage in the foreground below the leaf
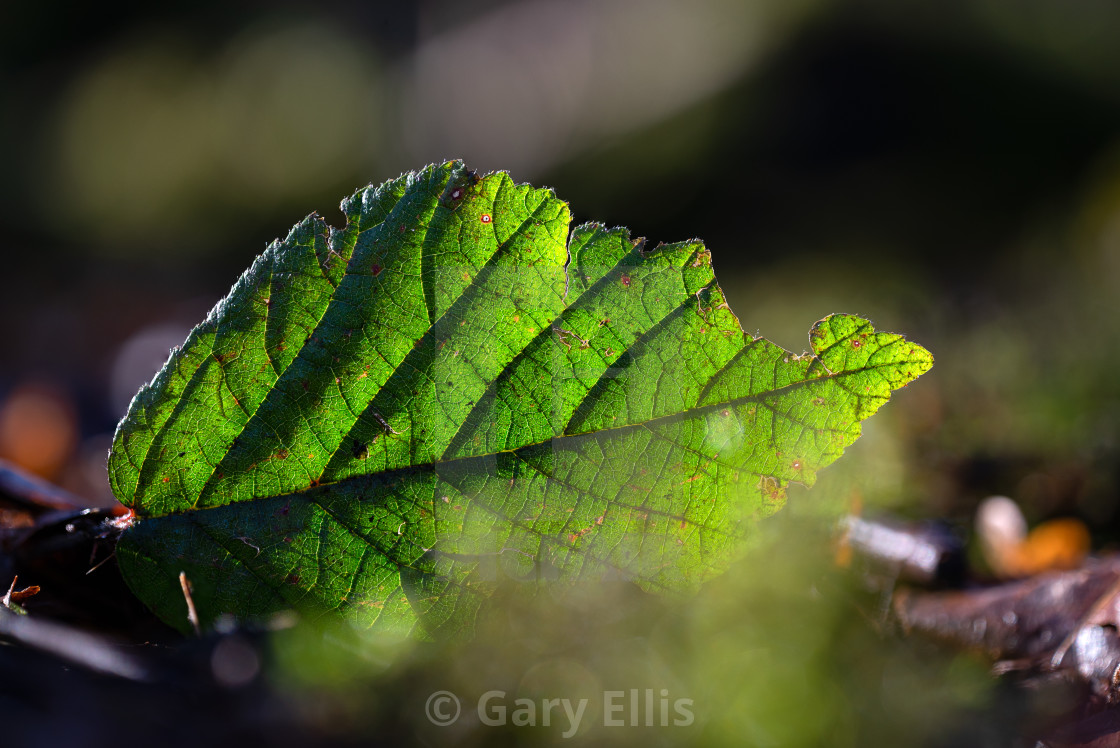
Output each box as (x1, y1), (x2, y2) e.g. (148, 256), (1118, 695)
(270, 515), (999, 746)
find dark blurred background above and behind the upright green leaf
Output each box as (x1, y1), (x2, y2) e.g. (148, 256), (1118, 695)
(0, 0), (1120, 743)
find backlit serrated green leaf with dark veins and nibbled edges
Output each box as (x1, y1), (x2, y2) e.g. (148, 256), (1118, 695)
(109, 162), (932, 635)
